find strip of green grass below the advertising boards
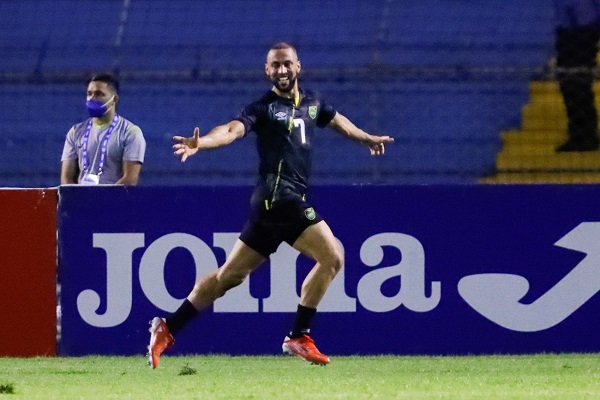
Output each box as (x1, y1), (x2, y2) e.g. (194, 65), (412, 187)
(0, 354), (600, 400)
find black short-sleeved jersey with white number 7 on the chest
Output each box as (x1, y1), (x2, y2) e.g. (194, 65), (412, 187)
(235, 90), (336, 208)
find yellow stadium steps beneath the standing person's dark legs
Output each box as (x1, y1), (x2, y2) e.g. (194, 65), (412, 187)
(481, 81), (600, 183)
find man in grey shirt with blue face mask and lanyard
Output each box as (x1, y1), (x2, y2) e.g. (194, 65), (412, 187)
(60, 74), (146, 185)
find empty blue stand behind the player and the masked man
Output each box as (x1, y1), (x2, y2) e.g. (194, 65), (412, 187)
(0, 0), (554, 186)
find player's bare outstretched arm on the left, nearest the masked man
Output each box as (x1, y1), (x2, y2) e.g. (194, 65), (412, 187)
(173, 120), (246, 162)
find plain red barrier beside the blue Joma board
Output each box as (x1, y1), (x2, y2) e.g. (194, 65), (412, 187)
(0, 189), (57, 357)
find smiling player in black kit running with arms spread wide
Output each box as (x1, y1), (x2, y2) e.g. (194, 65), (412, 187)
(148, 42), (393, 368)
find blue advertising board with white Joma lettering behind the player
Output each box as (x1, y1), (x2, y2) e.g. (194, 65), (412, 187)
(58, 185), (600, 355)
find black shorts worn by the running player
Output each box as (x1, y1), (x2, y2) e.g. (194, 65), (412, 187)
(240, 199), (323, 258)
